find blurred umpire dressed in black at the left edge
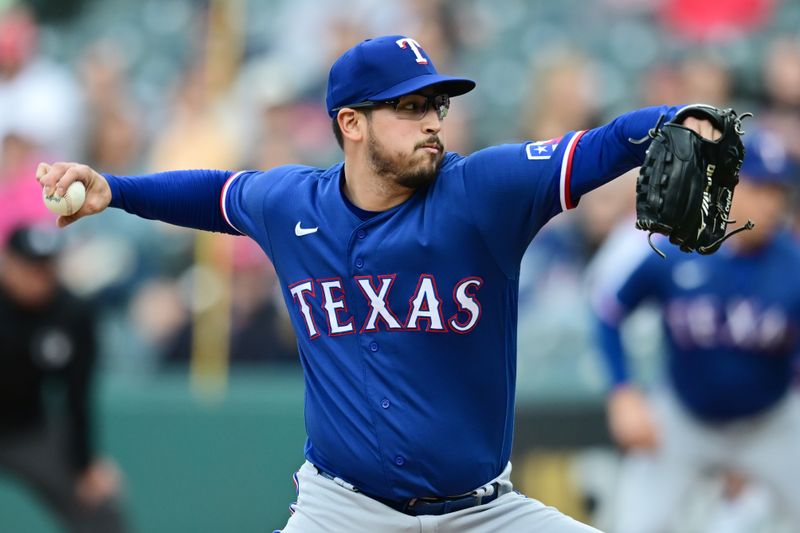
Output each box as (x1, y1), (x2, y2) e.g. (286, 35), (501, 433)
(0, 226), (124, 533)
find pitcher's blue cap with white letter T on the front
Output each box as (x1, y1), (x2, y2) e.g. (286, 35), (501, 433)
(326, 35), (475, 118)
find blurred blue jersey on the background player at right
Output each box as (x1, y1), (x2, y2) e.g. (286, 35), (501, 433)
(596, 231), (800, 421)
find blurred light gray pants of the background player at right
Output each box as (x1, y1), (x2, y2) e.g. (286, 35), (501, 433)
(614, 388), (800, 533)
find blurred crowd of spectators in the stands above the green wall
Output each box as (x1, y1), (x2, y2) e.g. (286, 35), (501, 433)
(0, 0), (800, 390)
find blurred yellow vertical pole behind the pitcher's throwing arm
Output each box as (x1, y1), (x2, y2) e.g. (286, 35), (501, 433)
(190, 0), (246, 401)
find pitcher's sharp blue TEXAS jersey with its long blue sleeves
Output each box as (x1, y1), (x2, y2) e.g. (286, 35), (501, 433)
(107, 107), (677, 499)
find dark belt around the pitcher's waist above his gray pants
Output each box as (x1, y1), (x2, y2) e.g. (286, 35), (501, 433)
(314, 465), (500, 516)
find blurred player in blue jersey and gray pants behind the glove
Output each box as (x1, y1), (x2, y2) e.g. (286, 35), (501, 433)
(594, 132), (800, 533)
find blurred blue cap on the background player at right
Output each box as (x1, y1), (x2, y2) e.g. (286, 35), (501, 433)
(740, 128), (800, 186)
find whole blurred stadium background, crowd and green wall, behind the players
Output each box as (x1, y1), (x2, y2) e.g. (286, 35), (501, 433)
(0, 0), (800, 533)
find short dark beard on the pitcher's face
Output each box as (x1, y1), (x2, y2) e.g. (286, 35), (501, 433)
(367, 128), (444, 190)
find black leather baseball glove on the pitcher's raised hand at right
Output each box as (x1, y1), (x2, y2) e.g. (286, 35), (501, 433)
(631, 104), (754, 257)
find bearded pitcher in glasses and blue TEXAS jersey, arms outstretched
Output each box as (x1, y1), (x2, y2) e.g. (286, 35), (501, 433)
(37, 35), (718, 533)
